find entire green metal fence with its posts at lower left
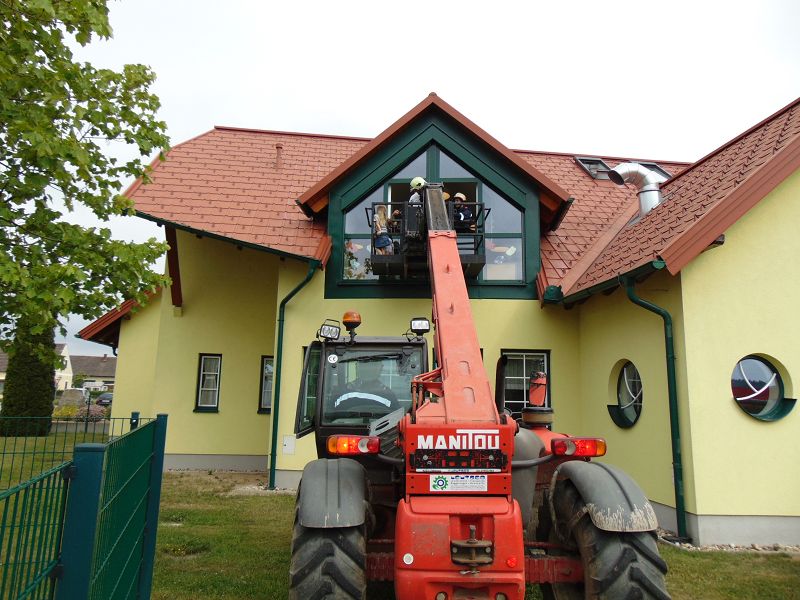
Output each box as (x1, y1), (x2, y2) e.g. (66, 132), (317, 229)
(0, 413), (167, 600)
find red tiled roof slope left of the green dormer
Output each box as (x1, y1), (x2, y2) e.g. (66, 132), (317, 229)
(127, 127), (367, 260)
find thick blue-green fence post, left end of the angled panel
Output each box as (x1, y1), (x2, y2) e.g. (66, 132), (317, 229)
(56, 444), (105, 600)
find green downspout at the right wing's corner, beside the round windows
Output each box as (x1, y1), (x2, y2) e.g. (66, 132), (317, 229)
(621, 272), (688, 539)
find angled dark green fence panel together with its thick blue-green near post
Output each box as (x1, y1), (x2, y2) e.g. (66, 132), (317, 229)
(55, 415), (167, 600)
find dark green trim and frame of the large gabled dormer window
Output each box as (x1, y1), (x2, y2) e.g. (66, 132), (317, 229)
(325, 114), (541, 299)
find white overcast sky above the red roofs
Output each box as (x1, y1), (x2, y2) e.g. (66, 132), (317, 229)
(59, 0), (800, 354)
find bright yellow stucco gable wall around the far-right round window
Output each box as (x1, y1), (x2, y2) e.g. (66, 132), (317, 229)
(683, 171), (800, 515)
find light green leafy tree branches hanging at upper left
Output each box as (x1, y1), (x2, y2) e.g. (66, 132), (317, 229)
(0, 0), (168, 346)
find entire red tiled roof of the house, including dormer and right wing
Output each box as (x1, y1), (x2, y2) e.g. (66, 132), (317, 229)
(129, 95), (800, 304)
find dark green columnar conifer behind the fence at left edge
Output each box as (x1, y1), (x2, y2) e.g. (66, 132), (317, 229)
(0, 318), (56, 436)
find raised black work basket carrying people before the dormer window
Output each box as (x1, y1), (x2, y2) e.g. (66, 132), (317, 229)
(364, 178), (491, 279)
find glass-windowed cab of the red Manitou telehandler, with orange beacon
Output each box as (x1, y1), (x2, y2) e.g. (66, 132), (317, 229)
(295, 313), (430, 457)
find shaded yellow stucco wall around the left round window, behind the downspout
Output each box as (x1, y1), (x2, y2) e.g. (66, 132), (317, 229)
(576, 272), (693, 510)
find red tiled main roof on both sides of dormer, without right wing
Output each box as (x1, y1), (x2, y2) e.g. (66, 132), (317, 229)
(128, 119), (686, 276)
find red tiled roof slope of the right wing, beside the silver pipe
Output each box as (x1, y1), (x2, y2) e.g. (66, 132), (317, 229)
(564, 94), (800, 295)
